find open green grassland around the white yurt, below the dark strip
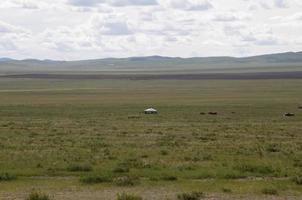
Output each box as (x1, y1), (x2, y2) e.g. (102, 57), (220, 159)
(0, 79), (302, 200)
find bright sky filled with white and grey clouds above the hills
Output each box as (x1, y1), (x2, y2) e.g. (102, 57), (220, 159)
(0, 0), (302, 60)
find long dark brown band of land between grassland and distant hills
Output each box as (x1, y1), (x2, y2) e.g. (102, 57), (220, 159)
(0, 71), (302, 80)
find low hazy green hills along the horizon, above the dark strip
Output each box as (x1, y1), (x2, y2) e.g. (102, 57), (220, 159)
(0, 52), (302, 74)
